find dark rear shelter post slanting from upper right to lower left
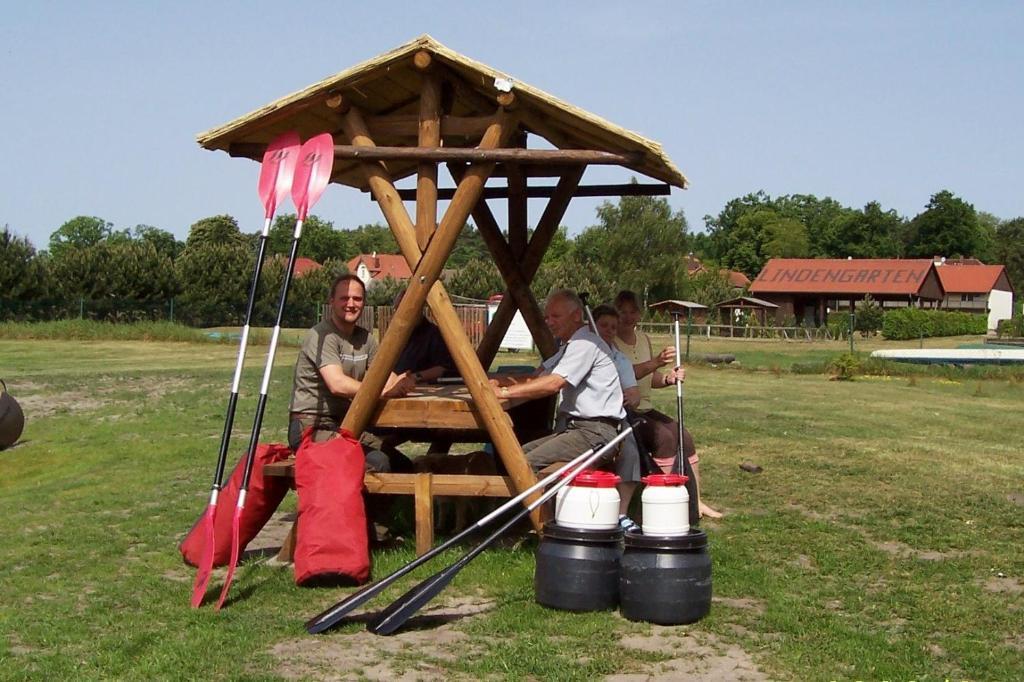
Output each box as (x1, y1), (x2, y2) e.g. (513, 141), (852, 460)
(473, 166), (586, 367)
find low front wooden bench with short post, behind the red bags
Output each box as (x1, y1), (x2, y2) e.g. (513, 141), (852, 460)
(263, 458), (560, 561)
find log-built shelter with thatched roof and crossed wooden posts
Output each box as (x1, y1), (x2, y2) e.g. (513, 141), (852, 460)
(198, 36), (687, 532)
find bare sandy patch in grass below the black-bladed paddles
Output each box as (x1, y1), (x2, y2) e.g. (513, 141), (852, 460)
(270, 596), (497, 682)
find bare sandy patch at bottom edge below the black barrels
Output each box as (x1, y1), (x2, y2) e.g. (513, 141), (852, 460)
(604, 626), (772, 682)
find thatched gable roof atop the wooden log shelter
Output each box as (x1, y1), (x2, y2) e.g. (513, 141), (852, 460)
(197, 35), (687, 188)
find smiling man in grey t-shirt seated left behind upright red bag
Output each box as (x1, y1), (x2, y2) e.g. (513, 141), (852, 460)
(288, 274), (416, 471)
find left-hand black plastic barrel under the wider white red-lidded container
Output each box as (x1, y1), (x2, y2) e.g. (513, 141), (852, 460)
(534, 522), (623, 611)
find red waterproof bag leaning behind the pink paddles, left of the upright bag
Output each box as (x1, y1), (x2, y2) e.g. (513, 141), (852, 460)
(178, 443), (292, 566)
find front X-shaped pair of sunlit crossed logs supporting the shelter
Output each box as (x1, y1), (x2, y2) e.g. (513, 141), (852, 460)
(343, 109), (557, 529)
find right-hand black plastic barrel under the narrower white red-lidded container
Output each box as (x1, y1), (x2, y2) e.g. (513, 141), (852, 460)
(618, 529), (711, 625)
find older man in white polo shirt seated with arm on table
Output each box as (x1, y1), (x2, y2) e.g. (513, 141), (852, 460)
(490, 289), (626, 469)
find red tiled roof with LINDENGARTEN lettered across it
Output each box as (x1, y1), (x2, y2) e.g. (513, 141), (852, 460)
(751, 258), (941, 295)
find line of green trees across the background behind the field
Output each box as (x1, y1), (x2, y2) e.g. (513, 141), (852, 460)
(0, 184), (1024, 326)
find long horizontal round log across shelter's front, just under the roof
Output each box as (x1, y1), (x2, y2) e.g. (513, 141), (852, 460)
(334, 144), (643, 166)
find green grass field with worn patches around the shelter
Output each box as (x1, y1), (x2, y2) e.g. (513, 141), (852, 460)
(0, 331), (1024, 680)
